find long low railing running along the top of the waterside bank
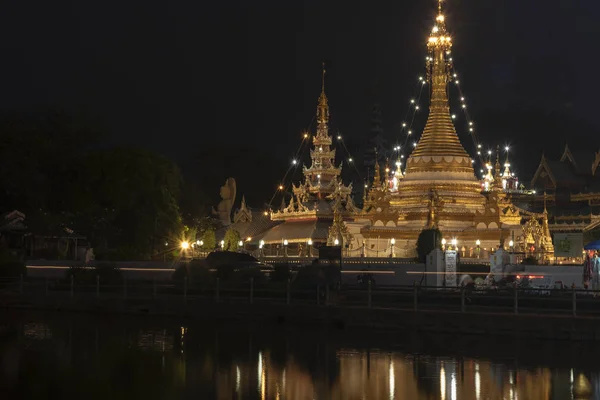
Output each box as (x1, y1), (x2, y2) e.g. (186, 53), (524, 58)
(0, 278), (600, 318)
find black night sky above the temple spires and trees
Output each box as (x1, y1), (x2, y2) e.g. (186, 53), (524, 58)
(0, 0), (600, 203)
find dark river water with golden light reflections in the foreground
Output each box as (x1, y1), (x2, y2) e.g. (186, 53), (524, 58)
(0, 312), (600, 400)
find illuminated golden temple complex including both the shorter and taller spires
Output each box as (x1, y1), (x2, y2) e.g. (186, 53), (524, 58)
(224, 0), (568, 258)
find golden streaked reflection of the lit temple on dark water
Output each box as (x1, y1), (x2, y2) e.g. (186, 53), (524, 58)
(217, 350), (556, 400)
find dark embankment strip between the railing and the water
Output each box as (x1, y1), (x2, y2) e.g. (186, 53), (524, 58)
(0, 295), (600, 341)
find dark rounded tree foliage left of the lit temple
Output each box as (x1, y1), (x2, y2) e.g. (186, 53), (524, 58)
(0, 113), (182, 260)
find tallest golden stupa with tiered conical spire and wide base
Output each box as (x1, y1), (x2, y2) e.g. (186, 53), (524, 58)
(349, 0), (522, 257)
